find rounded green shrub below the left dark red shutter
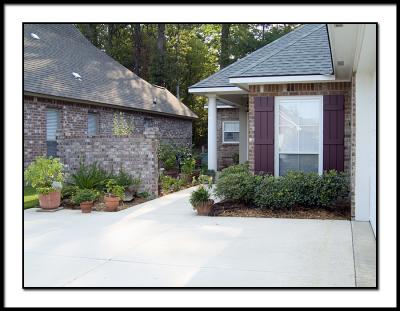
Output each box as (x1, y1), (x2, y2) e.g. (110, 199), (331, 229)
(215, 164), (261, 203)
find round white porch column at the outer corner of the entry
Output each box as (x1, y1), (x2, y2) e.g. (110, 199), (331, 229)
(207, 94), (217, 171)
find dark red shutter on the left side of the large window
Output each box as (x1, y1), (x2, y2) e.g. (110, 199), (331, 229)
(254, 96), (274, 174)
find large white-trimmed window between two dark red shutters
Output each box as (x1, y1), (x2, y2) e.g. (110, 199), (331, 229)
(275, 96), (323, 176)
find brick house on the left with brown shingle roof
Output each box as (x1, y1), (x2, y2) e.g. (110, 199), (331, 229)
(24, 24), (197, 171)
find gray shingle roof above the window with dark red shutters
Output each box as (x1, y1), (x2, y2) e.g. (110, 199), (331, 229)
(191, 24), (333, 88)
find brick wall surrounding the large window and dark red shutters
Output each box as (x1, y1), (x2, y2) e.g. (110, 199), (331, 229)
(248, 82), (355, 200)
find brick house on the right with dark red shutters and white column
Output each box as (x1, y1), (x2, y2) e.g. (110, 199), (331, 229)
(189, 24), (376, 232)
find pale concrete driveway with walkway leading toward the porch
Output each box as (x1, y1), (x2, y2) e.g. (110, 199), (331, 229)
(24, 189), (375, 287)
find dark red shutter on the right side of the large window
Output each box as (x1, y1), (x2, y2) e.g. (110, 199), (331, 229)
(323, 95), (344, 171)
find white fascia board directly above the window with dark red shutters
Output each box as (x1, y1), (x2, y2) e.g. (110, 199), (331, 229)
(229, 75), (335, 84)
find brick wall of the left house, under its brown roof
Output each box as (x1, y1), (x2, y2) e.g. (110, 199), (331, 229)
(24, 96), (192, 167)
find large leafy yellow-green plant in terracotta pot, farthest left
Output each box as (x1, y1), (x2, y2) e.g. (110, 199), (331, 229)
(24, 156), (64, 210)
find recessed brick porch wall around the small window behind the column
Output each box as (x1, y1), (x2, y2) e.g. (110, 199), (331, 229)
(217, 108), (239, 170)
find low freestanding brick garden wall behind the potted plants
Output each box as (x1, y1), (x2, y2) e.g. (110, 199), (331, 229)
(58, 128), (159, 196)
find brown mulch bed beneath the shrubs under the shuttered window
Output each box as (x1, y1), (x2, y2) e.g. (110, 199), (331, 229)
(211, 201), (351, 220)
